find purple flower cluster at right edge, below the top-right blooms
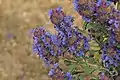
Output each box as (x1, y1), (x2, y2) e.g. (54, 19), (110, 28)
(102, 29), (120, 68)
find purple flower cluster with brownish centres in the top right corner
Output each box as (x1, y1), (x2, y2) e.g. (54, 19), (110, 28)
(74, 0), (120, 27)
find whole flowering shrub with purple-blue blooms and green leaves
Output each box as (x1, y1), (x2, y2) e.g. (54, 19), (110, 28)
(32, 0), (120, 80)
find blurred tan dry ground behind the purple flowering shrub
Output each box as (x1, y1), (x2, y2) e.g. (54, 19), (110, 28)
(0, 0), (81, 80)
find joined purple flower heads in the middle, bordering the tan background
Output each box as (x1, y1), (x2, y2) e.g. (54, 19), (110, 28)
(33, 7), (89, 80)
